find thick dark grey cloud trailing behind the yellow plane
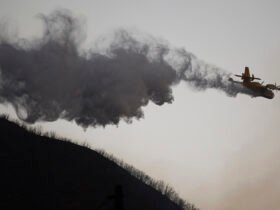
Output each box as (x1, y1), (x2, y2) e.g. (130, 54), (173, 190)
(0, 11), (249, 127)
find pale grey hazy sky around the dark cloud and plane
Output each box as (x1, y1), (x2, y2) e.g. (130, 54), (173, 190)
(0, 0), (280, 210)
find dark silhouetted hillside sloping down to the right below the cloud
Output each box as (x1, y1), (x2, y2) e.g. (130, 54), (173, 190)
(0, 118), (196, 210)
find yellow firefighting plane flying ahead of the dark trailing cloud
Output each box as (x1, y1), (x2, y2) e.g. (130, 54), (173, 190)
(229, 67), (280, 99)
